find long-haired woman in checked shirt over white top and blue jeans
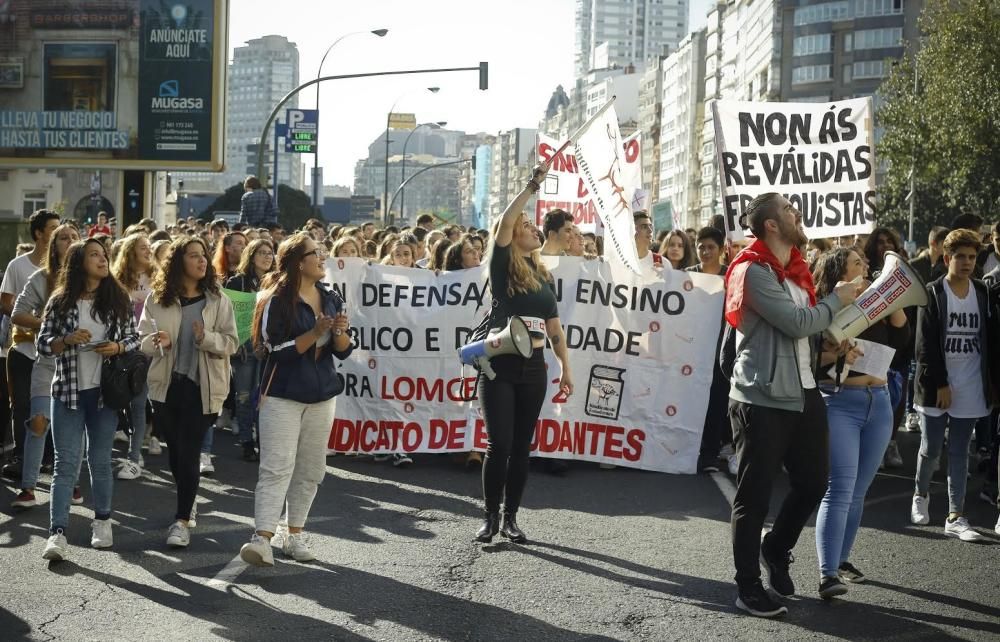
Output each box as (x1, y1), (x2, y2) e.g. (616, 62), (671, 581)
(37, 238), (139, 561)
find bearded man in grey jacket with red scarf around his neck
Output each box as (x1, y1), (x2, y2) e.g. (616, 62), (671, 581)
(725, 192), (860, 617)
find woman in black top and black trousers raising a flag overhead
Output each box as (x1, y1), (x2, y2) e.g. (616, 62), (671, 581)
(476, 164), (573, 543)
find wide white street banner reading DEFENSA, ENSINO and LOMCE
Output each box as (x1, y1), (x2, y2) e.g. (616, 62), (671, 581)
(327, 257), (722, 473)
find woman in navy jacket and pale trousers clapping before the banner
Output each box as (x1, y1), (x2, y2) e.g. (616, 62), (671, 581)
(240, 233), (353, 566)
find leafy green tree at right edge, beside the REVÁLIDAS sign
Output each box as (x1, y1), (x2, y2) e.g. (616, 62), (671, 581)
(876, 0), (1000, 239)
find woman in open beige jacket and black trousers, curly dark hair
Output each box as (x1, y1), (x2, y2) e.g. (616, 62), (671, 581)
(139, 236), (237, 548)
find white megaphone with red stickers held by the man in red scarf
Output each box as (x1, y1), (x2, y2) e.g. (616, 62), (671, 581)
(826, 252), (927, 343)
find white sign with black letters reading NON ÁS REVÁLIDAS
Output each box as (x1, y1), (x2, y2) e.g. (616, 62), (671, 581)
(712, 97), (875, 239)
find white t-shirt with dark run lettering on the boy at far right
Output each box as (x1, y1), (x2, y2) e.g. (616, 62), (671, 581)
(917, 279), (990, 419)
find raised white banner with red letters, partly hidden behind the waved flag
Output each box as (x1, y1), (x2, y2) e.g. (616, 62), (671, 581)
(535, 132), (649, 233)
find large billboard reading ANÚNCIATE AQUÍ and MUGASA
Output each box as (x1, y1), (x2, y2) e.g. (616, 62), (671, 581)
(0, 0), (229, 171)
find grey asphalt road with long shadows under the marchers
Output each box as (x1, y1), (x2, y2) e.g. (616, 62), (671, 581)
(0, 424), (1000, 641)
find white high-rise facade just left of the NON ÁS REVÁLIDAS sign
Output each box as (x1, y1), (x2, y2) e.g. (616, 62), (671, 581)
(658, 29), (714, 228)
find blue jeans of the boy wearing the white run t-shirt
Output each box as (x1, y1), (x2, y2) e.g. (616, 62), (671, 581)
(916, 412), (979, 513)
